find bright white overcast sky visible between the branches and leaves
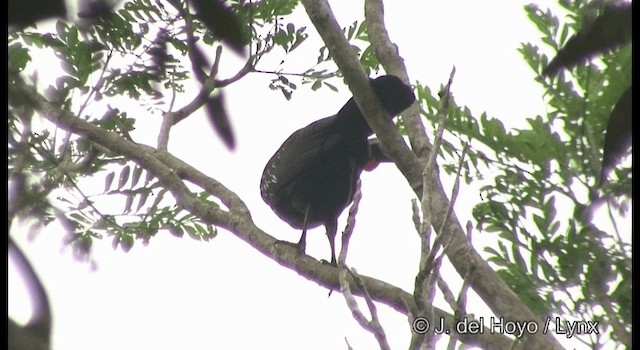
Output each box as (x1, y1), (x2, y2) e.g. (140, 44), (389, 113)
(9, 0), (624, 350)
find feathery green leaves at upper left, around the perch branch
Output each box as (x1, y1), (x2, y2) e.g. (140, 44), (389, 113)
(8, 0), (300, 253)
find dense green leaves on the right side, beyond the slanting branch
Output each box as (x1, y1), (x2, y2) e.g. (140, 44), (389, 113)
(418, 2), (631, 347)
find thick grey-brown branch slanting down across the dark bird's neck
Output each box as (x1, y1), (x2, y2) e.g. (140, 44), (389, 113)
(302, 0), (562, 349)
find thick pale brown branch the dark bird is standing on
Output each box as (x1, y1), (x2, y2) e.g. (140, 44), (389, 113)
(16, 76), (523, 349)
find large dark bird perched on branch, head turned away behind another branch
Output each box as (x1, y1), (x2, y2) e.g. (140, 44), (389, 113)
(260, 75), (415, 266)
